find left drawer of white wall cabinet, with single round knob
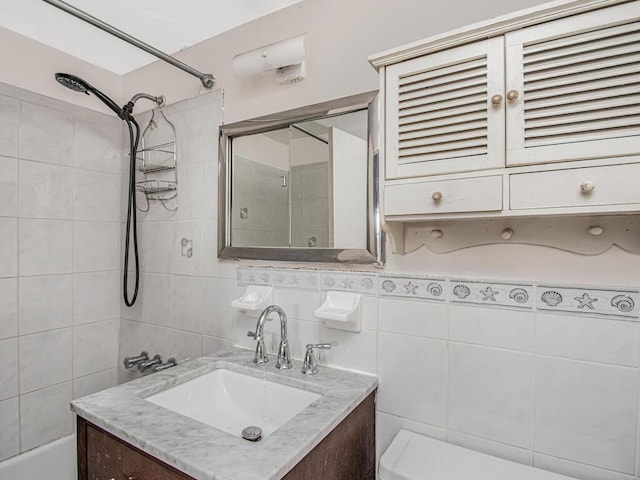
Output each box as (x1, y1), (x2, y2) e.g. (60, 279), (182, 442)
(384, 175), (502, 215)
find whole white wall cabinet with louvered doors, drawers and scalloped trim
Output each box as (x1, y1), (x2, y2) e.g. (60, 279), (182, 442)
(370, 0), (640, 254)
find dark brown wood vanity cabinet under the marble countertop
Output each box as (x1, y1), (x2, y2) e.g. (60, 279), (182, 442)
(77, 393), (375, 480)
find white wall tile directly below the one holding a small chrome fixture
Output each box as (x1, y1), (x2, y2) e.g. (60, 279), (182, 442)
(171, 275), (202, 333)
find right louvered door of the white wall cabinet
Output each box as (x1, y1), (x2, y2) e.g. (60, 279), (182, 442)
(505, 2), (640, 165)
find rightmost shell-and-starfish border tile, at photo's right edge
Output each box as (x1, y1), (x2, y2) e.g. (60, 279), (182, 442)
(537, 285), (640, 319)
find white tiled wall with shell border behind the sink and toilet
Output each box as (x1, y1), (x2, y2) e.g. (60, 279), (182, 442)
(237, 268), (640, 480)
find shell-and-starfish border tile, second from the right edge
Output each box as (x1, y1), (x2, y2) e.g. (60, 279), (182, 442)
(449, 279), (534, 309)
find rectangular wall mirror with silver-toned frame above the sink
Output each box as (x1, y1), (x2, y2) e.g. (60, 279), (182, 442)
(218, 92), (384, 264)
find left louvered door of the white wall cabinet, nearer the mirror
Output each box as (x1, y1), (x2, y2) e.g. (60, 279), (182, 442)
(385, 38), (504, 179)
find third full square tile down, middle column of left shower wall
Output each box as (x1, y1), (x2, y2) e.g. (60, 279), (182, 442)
(19, 219), (73, 275)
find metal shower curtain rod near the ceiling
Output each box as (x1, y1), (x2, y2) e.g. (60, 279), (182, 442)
(43, 0), (216, 88)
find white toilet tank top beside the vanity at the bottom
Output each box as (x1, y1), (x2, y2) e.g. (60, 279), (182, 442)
(378, 430), (575, 480)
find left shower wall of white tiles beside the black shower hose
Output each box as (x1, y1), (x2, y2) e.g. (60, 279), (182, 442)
(0, 79), (121, 460)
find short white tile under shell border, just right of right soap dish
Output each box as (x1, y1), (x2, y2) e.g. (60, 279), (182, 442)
(379, 297), (448, 339)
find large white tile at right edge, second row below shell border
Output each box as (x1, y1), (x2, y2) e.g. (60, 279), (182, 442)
(534, 357), (638, 474)
